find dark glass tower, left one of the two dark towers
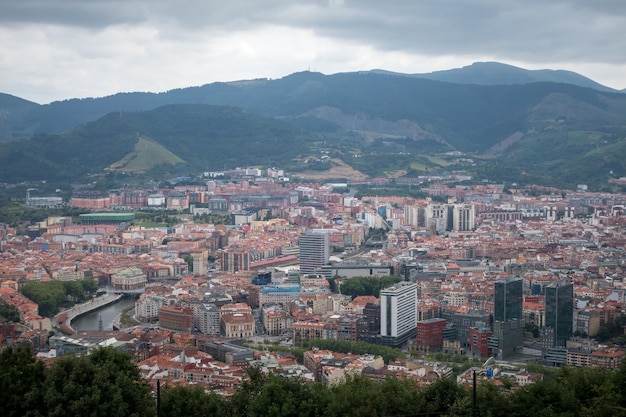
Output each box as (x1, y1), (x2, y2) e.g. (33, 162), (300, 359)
(490, 277), (524, 359)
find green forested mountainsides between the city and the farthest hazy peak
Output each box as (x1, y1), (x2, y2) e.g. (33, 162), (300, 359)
(0, 67), (626, 186)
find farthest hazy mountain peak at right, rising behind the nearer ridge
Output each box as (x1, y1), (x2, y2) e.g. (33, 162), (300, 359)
(368, 62), (618, 93)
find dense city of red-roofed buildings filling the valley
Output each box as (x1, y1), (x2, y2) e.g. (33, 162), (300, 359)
(0, 163), (626, 394)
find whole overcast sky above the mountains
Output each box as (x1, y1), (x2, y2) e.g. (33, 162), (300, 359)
(0, 0), (626, 104)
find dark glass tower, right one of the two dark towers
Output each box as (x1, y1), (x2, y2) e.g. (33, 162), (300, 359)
(545, 282), (574, 348)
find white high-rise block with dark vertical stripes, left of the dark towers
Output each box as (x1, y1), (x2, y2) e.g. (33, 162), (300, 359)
(380, 281), (417, 346)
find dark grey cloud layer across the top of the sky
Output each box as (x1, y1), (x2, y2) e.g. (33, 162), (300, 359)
(0, 0), (626, 62)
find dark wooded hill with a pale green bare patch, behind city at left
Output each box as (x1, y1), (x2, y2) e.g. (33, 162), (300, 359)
(0, 104), (313, 181)
